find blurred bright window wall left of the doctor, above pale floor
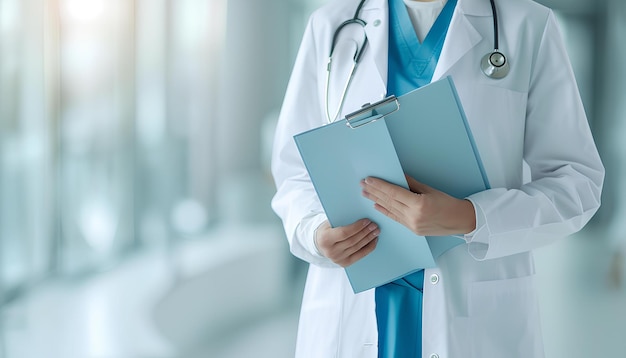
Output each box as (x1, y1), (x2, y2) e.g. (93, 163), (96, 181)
(0, 0), (226, 297)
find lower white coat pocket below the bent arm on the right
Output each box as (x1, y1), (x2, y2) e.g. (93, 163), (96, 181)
(469, 276), (543, 358)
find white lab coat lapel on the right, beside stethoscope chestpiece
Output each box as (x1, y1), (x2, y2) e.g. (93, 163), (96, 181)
(432, 0), (491, 81)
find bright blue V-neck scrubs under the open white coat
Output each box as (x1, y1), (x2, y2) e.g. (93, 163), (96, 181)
(375, 0), (456, 358)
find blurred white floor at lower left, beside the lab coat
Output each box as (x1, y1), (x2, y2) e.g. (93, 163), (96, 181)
(0, 226), (303, 358)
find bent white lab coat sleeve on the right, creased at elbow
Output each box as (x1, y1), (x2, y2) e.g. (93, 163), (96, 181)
(466, 13), (604, 260)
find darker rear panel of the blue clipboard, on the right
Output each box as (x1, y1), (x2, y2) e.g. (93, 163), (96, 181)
(387, 77), (490, 257)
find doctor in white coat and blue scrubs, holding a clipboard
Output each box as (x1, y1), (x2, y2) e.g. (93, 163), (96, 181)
(272, 0), (604, 358)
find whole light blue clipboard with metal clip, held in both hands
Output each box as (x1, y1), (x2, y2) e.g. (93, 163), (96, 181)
(294, 77), (489, 293)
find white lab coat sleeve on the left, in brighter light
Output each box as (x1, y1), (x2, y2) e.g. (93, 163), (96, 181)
(272, 17), (338, 267)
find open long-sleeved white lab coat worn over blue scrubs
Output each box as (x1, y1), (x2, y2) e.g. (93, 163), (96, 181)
(272, 0), (604, 358)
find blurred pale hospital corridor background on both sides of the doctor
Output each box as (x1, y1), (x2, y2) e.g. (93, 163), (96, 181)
(0, 0), (626, 358)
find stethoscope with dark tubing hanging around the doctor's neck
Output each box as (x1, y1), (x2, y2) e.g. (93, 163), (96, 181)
(325, 0), (509, 123)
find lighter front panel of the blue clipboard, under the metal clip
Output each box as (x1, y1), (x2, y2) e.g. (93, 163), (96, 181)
(295, 118), (435, 293)
